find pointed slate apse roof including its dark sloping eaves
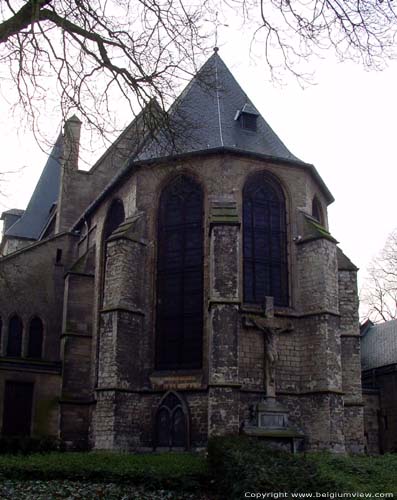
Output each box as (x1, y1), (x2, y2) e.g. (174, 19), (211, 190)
(73, 52), (334, 229)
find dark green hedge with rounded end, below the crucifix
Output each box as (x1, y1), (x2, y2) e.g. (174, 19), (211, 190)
(208, 436), (397, 499)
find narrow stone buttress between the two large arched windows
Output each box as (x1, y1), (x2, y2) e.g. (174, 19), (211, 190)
(208, 199), (241, 436)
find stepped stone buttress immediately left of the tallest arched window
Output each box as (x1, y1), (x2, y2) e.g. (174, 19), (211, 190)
(94, 215), (147, 450)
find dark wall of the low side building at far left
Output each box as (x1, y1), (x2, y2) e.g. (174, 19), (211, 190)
(0, 234), (76, 437)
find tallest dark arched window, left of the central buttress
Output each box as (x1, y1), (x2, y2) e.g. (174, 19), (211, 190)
(156, 176), (203, 369)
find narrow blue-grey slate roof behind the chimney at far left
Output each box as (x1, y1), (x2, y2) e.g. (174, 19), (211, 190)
(5, 134), (63, 240)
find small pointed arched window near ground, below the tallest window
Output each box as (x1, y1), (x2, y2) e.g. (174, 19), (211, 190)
(155, 392), (189, 449)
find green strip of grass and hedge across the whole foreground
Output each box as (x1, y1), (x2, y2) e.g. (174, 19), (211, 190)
(0, 444), (397, 500)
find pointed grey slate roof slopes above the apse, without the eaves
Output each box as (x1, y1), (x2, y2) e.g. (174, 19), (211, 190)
(135, 52), (300, 162)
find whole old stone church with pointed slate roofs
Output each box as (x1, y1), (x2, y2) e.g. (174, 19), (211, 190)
(0, 49), (364, 452)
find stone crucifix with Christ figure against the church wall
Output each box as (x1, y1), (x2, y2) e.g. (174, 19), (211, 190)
(245, 297), (294, 398)
